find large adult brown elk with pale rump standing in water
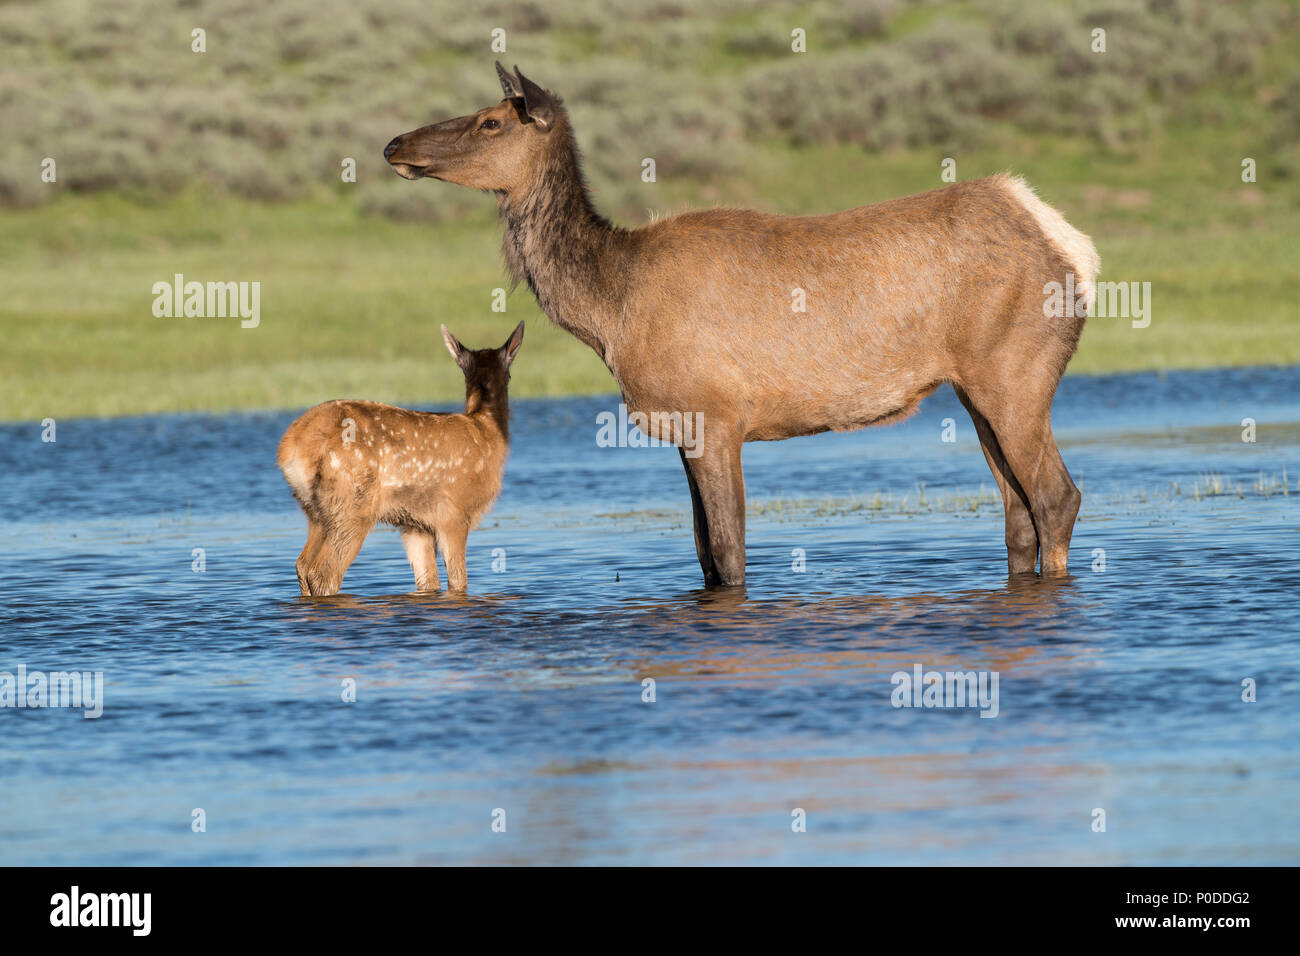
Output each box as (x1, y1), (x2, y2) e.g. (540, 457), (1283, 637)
(385, 64), (1100, 584)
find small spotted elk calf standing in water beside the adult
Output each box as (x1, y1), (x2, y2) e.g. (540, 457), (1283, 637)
(277, 323), (524, 596)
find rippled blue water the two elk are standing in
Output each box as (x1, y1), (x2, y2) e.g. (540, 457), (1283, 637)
(0, 368), (1300, 864)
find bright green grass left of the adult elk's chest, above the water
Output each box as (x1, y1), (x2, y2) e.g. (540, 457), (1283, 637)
(0, 182), (611, 419)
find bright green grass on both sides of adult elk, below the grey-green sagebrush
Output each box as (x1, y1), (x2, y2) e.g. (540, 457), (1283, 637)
(0, 119), (1300, 420)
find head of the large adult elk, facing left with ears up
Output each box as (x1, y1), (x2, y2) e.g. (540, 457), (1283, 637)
(384, 62), (559, 193)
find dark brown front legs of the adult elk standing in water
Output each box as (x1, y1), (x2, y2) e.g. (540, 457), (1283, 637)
(681, 436), (745, 587)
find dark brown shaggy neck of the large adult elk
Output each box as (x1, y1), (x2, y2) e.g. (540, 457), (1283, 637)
(499, 120), (625, 358)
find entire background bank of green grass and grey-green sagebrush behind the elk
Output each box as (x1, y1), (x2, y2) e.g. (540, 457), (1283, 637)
(10, 0), (1300, 420)
